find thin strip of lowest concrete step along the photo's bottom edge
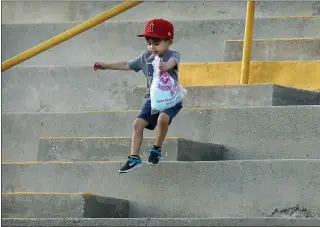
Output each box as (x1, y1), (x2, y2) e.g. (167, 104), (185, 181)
(1, 217), (320, 226)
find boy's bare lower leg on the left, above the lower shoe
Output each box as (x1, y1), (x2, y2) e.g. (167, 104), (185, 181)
(131, 118), (149, 156)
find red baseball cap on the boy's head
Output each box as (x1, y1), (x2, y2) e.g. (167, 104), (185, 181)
(138, 19), (174, 39)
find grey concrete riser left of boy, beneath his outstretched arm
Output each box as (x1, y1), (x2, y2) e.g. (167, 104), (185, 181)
(1, 66), (146, 112)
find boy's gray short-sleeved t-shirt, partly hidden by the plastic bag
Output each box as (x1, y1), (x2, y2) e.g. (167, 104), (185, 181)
(128, 50), (180, 97)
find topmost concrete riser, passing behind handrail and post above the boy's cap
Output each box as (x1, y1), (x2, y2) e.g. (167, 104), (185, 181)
(2, 1), (320, 23)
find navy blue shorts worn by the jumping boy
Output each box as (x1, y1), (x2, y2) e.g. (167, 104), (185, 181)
(138, 99), (182, 130)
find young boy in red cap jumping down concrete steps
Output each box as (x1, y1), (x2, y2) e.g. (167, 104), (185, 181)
(94, 19), (182, 173)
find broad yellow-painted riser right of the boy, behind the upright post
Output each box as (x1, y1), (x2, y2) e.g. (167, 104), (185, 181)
(179, 61), (320, 90)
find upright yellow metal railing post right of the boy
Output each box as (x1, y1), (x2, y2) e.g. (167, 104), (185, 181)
(240, 1), (256, 84)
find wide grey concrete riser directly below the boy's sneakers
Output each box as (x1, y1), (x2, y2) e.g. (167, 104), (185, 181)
(1, 159), (320, 218)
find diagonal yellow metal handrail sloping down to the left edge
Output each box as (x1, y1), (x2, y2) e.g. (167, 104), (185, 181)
(1, 1), (143, 72)
